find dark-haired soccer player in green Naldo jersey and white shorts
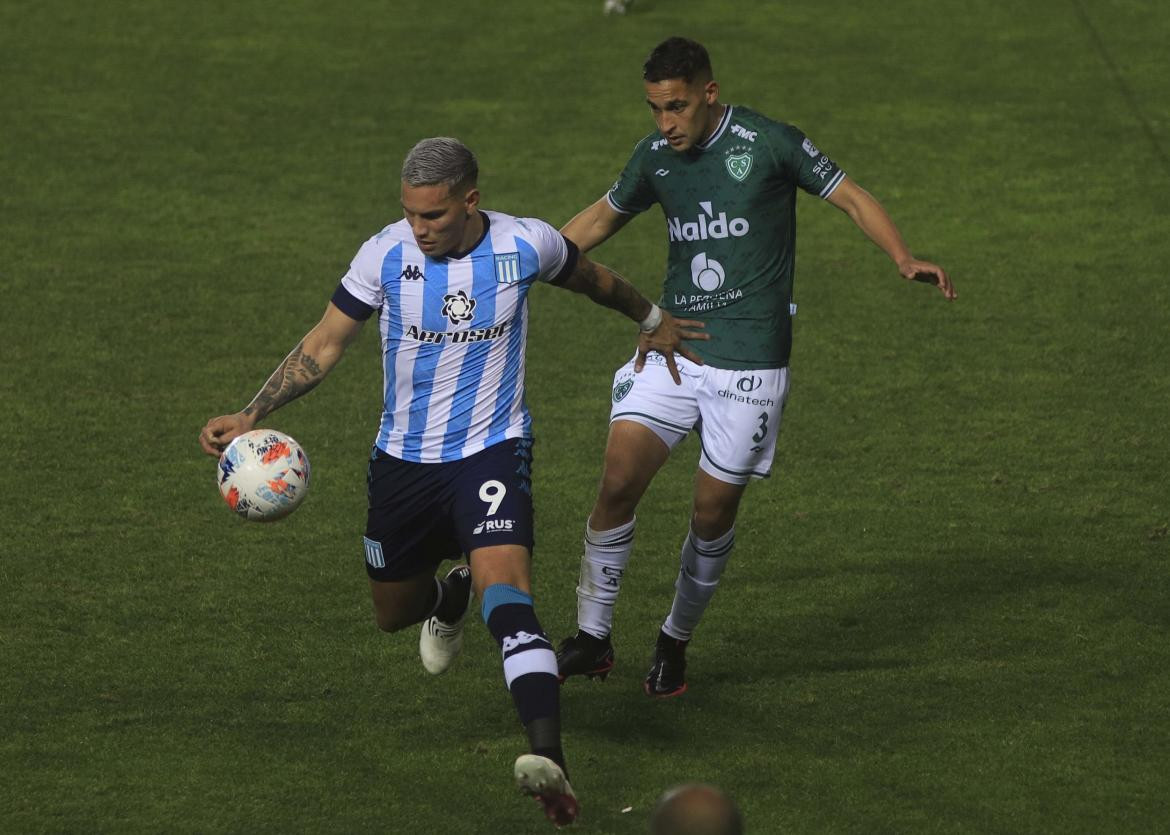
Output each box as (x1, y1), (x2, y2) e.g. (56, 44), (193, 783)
(557, 37), (956, 698)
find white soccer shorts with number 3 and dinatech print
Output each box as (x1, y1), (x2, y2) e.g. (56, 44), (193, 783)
(610, 353), (789, 484)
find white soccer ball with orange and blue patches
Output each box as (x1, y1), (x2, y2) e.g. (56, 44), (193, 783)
(216, 429), (309, 522)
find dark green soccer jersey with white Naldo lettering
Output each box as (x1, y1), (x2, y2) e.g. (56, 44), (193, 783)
(607, 105), (845, 368)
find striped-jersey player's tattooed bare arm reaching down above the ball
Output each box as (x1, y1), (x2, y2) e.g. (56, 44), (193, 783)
(199, 302), (364, 455)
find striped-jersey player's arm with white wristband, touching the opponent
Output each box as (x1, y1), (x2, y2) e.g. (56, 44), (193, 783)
(560, 255), (710, 384)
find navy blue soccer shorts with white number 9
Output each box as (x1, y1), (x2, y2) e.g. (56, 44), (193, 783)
(365, 439), (532, 581)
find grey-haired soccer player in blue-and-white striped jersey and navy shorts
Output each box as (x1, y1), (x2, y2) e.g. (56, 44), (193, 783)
(200, 137), (706, 824)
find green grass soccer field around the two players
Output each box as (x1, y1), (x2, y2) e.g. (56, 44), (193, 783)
(0, 0), (1170, 834)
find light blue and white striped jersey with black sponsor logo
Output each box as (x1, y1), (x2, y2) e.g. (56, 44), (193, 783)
(333, 212), (577, 463)
